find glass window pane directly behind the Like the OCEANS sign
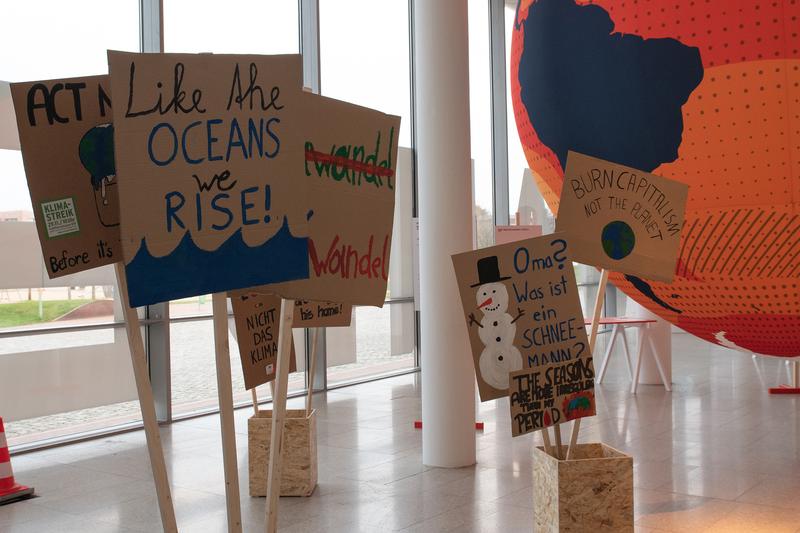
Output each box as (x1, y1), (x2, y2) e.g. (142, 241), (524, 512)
(164, 0), (305, 415)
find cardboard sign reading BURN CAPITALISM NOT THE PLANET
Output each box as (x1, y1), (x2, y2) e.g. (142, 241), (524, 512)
(556, 152), (689, 282)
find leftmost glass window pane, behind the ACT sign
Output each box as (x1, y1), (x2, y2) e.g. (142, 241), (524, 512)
(0, 0), (140, 445)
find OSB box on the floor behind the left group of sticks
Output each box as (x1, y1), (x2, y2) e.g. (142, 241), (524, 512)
(247, 409), (317, 496)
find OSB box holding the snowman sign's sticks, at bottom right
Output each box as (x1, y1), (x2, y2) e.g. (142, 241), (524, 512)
(533, 443), (633, 533)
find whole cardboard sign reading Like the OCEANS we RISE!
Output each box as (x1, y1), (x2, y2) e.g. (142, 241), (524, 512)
(108, 51), (312, 306)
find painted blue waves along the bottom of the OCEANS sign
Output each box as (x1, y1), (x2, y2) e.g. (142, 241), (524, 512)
(125, 218), (309, 307)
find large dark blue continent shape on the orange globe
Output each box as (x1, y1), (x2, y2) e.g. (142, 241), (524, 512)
(519, 0), (703, 172)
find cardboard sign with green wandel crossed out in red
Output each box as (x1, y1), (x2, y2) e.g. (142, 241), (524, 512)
(258, 93), (400, 307)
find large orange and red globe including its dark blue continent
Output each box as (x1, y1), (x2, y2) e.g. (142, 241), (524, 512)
(510, 0), (800, 357)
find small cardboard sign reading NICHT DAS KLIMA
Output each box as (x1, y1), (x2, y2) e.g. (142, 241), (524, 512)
(230, 291), (297, 389)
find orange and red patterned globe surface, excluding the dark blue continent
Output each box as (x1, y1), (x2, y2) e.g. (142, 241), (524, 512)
(510, 0), (800, 357)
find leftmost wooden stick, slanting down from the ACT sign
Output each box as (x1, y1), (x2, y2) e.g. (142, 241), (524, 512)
(114, 263), (178, 533)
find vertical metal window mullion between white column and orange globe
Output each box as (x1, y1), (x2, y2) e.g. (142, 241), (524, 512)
(489, 0), (509, 225)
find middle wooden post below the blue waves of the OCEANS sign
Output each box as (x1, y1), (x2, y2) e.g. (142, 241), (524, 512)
(211, 292), (242, 533)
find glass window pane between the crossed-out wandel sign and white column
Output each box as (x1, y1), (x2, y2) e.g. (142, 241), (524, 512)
(319, 0), (415, 384)
